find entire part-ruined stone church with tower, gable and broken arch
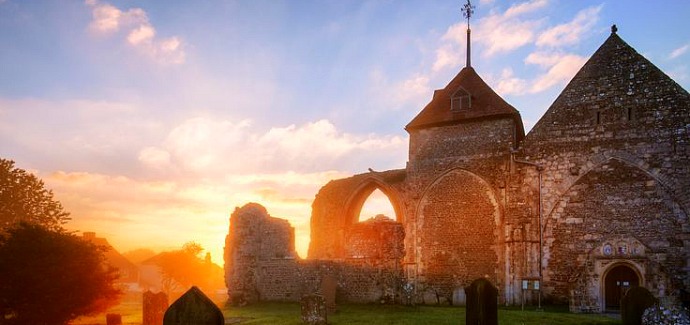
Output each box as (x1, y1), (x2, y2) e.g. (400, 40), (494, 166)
(225, 23), (690, 312)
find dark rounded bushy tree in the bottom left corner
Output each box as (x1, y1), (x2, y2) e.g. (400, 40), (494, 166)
(0, 222), (120, 325)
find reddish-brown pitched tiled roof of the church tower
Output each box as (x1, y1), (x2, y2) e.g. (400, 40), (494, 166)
(405, 67), (525, 139)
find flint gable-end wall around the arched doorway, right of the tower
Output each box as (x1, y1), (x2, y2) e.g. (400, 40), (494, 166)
(520, 34), (690, 311)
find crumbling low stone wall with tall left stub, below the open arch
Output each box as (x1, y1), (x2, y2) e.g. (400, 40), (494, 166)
(225, 203), (405, 304)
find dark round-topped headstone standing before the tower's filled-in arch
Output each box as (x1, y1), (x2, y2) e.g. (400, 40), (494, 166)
(465, 279), (498, 325)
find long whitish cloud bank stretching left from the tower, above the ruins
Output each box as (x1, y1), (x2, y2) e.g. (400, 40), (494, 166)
(139, 117), (406, 174)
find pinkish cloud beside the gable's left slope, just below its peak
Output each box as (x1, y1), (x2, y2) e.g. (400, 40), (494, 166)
(525, 52), (587, 93)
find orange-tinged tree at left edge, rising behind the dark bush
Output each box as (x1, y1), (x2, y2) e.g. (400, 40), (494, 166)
(0, 158), (69, 232)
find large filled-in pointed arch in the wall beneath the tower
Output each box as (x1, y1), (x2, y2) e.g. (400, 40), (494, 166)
(414, 168), (503, 297)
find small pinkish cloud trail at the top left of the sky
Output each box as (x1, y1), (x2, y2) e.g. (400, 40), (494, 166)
(85, 0), (186, 64)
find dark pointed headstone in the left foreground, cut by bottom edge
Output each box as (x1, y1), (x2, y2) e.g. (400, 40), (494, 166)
(163, 287), (225, 325)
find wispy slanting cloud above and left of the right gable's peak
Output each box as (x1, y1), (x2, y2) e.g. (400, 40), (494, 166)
(536, 5), (603, 47)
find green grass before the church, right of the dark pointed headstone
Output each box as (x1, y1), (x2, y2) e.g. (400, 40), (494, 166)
(223, 303), (620, 325)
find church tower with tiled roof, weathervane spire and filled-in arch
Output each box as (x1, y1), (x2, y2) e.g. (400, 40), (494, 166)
(405, 1), (525, 297)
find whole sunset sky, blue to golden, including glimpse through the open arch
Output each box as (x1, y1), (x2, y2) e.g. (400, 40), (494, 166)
(0, 0), (690, 265)
